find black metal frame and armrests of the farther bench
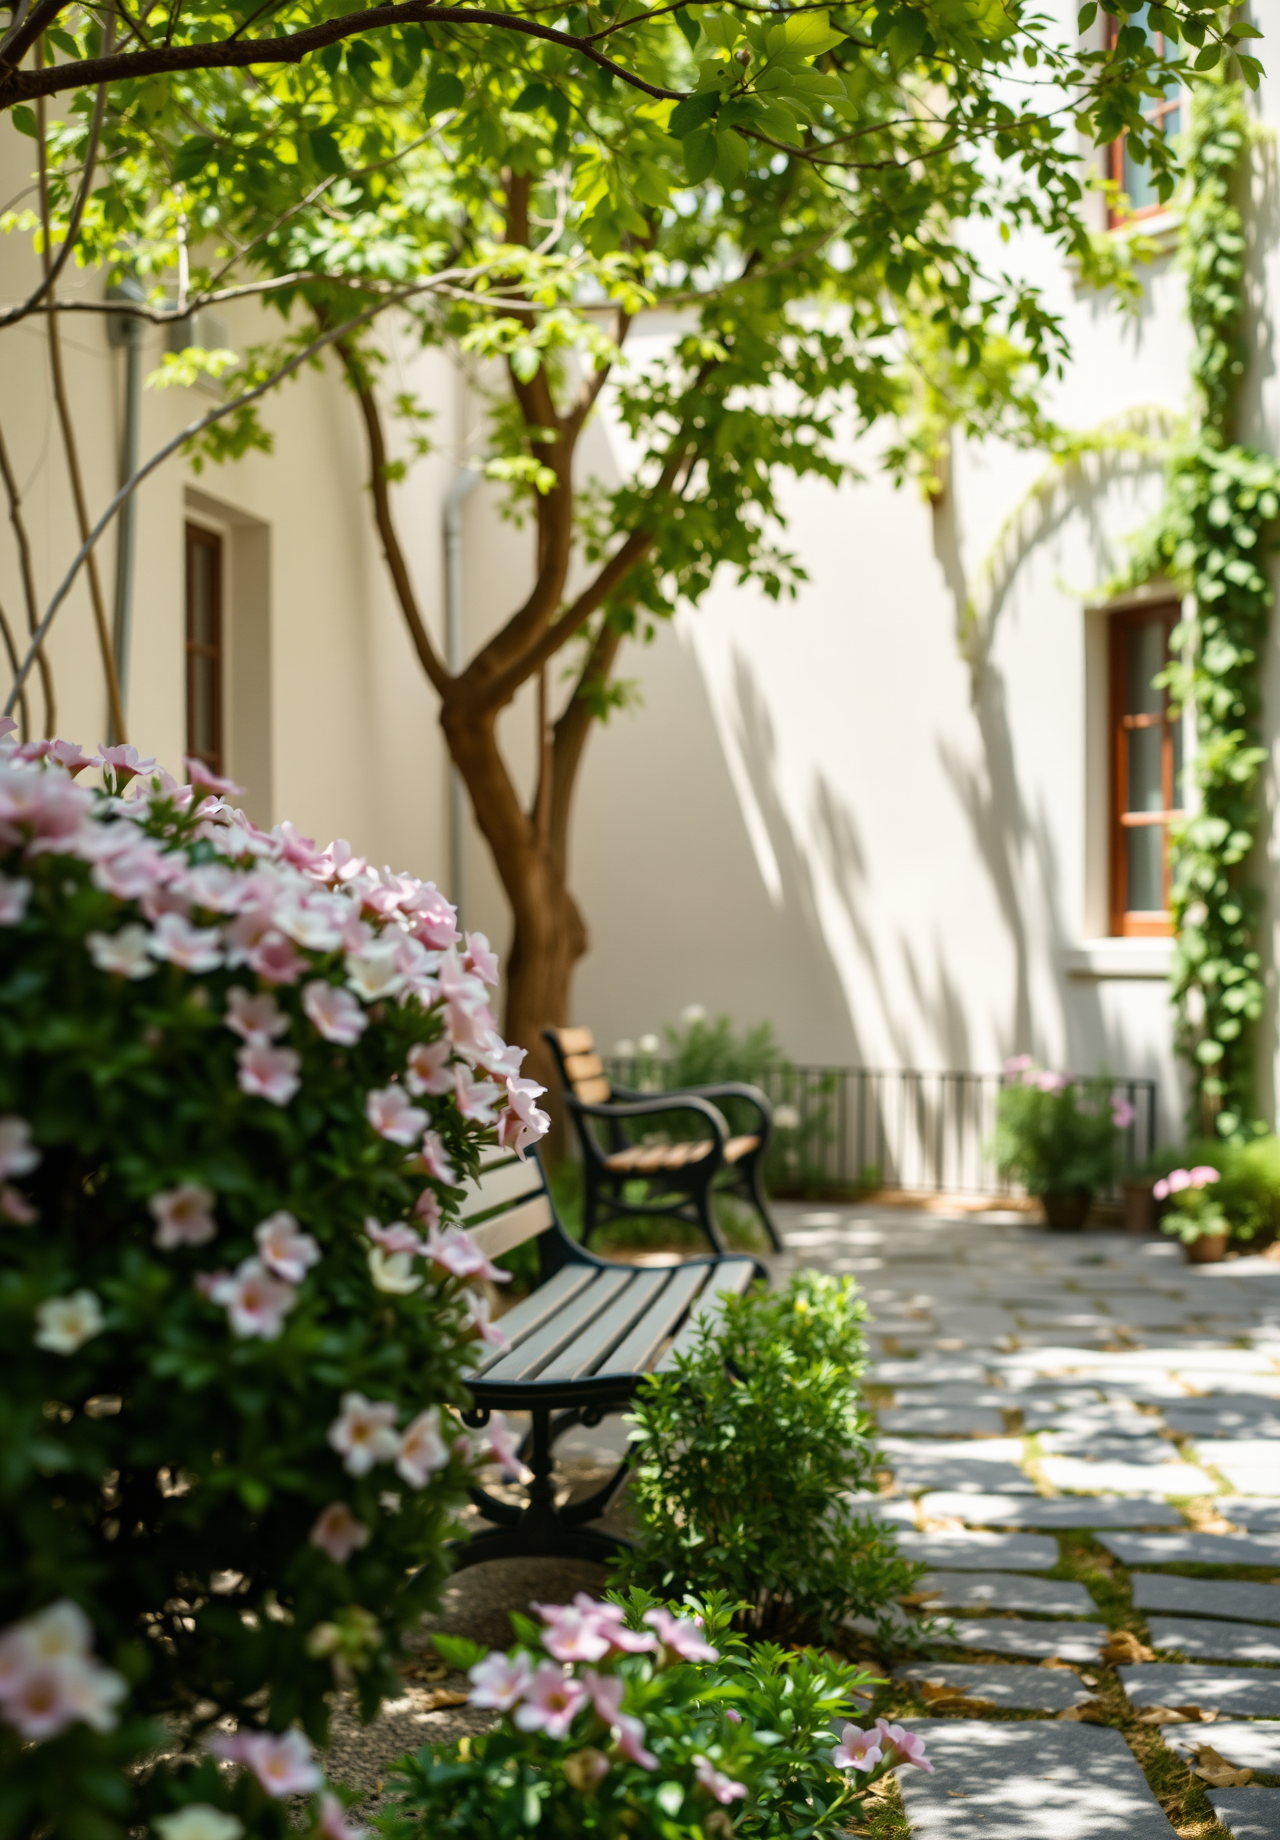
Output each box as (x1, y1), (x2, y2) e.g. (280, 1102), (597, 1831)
(543, 1029), (782, 1253)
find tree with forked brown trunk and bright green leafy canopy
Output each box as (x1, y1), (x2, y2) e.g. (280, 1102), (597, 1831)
(2, 0), (1256, 1089)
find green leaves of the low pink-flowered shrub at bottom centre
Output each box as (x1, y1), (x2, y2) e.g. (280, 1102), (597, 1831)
(379, 1590), (890, 1840)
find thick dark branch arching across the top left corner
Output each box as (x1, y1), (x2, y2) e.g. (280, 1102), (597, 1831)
(0, 0), (684, 110)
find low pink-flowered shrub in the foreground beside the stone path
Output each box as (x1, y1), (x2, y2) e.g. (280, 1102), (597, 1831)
(386, 1592), (932, 1840)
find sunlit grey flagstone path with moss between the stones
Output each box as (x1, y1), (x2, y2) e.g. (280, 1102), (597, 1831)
(776, 1203), (1280, 1840)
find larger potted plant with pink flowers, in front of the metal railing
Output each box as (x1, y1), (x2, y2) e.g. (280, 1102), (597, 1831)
(995, 1054), (1133, 1231)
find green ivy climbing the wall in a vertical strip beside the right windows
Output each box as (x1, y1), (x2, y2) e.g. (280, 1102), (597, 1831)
(1126, 81), (1280, 1137)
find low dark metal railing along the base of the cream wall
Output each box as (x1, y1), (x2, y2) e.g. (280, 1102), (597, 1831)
(609, 1058), (1157, 1194)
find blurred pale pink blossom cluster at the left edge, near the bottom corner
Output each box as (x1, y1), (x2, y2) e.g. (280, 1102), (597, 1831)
(0, 1597), (129, 1742)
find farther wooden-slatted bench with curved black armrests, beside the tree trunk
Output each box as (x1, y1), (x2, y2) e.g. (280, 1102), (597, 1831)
(543, 1029), (782, 1253)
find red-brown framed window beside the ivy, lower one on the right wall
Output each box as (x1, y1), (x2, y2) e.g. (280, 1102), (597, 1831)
(1111, 605), (1183, 937)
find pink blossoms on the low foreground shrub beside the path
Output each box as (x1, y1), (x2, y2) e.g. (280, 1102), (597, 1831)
(469, 1592), (747, 1803)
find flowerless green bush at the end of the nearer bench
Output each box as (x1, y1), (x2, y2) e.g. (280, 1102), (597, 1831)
(620, 1271), (916, 1641)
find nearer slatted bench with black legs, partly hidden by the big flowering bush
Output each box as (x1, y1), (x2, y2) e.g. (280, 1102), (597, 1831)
(454, 1150), (767, 1566)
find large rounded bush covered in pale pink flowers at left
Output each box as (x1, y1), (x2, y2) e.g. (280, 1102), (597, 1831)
(0, 725), (546, 1840)
